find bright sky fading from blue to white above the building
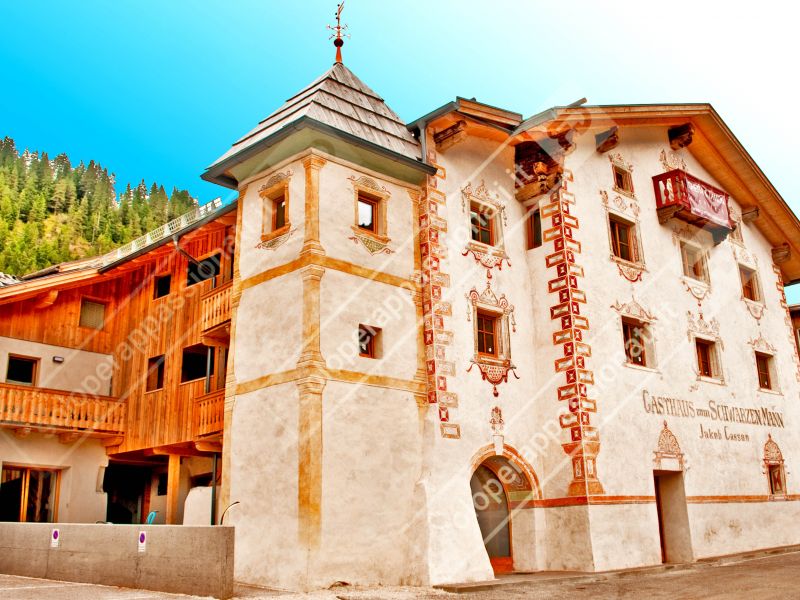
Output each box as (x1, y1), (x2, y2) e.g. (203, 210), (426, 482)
(0, 0), (800, 292)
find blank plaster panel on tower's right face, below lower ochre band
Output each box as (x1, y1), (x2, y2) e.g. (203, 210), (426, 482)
(315, 381), (425, 587)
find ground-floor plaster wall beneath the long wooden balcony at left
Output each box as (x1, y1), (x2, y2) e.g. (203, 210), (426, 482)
(0, 429), (108, 523)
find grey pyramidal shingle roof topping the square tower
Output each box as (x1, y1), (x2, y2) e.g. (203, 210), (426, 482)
(212, 63), (420, 167)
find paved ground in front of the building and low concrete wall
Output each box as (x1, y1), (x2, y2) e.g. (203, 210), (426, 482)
(0, 552), (800, 600)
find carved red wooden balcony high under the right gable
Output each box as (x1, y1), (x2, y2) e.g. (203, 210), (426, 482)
(653, 169), (735, 243)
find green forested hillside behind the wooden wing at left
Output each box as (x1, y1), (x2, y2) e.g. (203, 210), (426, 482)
(0, 137), (196, 276)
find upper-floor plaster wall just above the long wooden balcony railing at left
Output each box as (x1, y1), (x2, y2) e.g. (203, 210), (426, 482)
(0, 337), (113, 395)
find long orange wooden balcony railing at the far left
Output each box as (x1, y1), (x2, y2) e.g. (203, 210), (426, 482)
(0, 383), (125, 435)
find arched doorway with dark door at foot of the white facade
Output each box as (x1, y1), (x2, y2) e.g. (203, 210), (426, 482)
(470, 453), (536, 573)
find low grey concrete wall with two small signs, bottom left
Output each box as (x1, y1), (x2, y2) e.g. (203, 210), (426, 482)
(0, 523), (234, 599)
